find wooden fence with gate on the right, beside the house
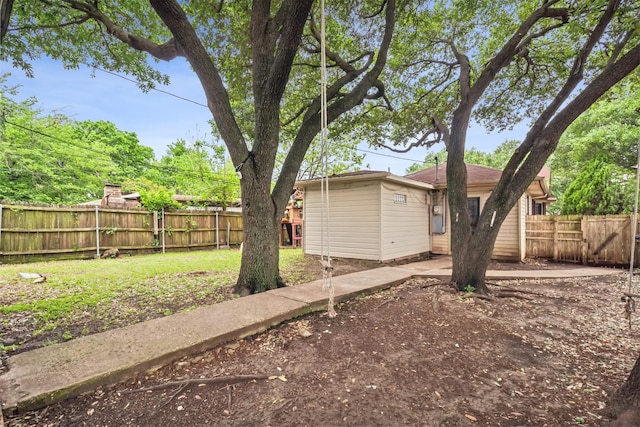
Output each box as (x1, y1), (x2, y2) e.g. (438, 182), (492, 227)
(526, 215), (640, 266)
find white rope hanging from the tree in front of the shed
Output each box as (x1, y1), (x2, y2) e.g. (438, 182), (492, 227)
(320, 0), (337, 317)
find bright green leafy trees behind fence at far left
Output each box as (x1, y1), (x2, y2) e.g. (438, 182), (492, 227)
(0, 79), (154, 204)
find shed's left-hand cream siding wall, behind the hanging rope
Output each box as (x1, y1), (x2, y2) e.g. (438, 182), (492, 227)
(302, 181), (381, 260)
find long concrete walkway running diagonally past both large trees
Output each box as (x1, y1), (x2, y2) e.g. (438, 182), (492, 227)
(0, 257), (622, 414)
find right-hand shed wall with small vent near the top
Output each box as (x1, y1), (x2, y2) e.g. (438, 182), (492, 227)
(381, 182), (431, 261)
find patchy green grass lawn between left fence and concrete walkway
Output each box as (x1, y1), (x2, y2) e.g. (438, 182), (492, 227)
(0, 249), (317, 354)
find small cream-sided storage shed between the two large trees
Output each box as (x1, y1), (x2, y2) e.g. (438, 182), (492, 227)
(296, 171), (433, 261)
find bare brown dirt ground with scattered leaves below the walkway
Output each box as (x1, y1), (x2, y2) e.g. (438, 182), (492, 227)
(5, 263), (640, 427)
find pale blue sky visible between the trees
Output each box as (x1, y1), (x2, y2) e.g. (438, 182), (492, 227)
(0, 59), (526, 175)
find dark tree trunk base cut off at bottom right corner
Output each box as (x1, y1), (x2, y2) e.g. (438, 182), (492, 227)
(606, 357), (640, 426)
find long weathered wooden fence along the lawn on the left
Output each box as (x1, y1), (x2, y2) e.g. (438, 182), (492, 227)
(0, 204), (243, 263)
